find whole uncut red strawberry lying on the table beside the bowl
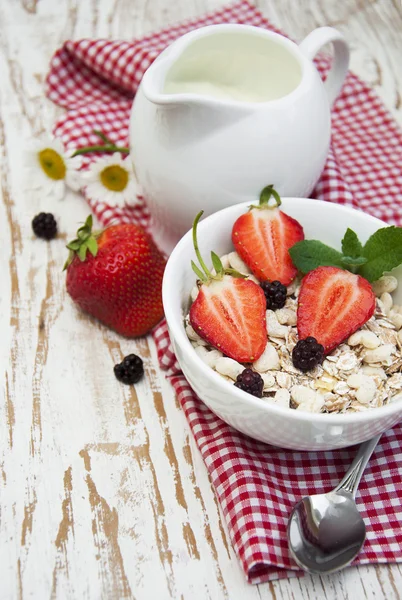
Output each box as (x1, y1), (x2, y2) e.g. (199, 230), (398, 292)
(65, 216), (166, 337)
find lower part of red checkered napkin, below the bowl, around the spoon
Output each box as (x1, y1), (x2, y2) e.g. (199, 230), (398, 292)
(154, 322), (402, 583)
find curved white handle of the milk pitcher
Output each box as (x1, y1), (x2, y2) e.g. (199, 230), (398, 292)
(299, 27), (349, 106)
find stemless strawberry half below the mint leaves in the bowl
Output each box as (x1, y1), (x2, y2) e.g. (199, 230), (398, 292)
(297, 267), (375, 354)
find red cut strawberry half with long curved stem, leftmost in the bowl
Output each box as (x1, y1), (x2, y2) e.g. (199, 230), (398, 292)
(190, 275), (267, 363)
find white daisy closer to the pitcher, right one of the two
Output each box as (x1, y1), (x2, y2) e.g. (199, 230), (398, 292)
(83, 152), (138, 207)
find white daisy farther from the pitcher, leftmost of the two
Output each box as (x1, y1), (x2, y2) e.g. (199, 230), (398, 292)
(25, 137), (82, 200)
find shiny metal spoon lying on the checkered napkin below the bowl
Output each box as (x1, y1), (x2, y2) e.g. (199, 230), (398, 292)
(288, 434), (381, 573)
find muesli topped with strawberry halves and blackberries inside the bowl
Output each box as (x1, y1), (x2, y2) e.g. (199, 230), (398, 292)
(186, 190), (402, 413)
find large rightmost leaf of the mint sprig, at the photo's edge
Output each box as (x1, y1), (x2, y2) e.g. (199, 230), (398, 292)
(359, 226), (402, 282)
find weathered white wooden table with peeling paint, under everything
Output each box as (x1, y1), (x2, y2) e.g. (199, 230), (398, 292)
(0, 0), (402, 600)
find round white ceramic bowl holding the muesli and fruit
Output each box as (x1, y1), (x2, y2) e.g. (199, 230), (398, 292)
(163, 198), (402, 450)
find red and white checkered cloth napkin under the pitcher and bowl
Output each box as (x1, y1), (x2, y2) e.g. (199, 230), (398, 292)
(47, 1), (402, 583)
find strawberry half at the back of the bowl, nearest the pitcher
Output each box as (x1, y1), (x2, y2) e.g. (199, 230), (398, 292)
(232, 186), (304, 285)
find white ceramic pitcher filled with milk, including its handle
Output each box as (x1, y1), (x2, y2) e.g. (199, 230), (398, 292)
(130, 25), (349, 252)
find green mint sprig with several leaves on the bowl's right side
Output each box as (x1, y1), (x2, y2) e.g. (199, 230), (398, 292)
(289, 225), (402, 283)
